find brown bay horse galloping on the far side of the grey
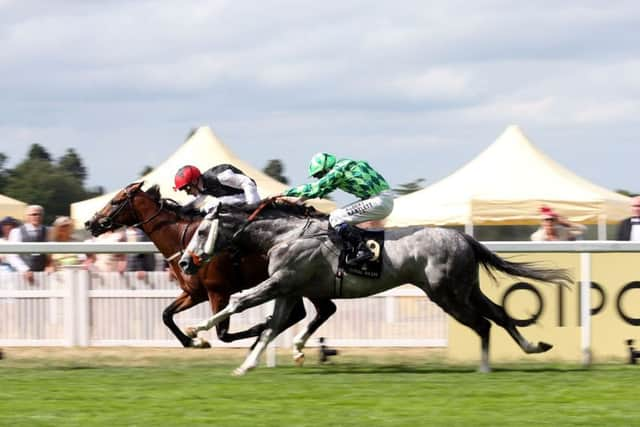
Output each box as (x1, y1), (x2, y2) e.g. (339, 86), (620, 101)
(85, 182), (335, 354)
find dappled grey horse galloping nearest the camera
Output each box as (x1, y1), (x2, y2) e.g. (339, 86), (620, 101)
(188, 201), (572, 375)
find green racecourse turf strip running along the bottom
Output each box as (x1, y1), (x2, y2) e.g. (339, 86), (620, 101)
(0, 348), (640, 427)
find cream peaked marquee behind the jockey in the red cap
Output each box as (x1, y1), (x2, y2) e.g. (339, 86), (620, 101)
(71, 127), (335, 227)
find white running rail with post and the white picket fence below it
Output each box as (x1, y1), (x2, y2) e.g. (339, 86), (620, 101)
(0, 241), (640, 362)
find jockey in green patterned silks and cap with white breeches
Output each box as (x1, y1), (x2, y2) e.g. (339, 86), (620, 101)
(283, 153), (393, 264)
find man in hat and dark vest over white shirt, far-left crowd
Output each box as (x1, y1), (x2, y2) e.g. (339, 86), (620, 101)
(7, 205), (49, 283)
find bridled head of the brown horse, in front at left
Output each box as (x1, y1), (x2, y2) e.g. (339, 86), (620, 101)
(84, 182), (161, 236)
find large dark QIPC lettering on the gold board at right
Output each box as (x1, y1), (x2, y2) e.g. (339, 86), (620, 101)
(501, 281), (640, 326)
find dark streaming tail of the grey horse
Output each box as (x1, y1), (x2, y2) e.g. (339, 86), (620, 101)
(461, 233), (573, 285)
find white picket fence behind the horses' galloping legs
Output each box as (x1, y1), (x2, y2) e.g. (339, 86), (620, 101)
(0, 260), (447, 347)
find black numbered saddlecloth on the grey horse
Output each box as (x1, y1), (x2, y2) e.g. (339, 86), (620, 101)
(336, 227), (384, 278)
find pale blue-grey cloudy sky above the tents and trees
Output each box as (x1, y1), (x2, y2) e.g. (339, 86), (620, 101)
(0, 0), (640, 201)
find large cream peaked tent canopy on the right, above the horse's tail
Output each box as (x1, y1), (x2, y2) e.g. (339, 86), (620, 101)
(385, 125), (631, 227)
